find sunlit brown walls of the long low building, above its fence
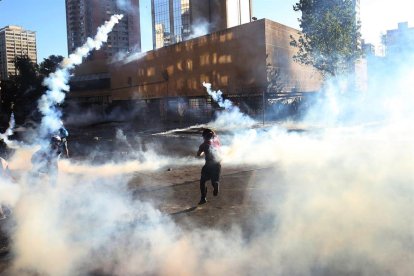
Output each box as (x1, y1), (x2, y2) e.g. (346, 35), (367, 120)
(110, 19), (321, 100)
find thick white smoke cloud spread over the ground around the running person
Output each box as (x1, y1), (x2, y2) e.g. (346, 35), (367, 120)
(0, 12), (414, 275)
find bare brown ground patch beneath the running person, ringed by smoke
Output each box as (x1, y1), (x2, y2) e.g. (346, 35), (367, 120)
(130, 166), (280, 231)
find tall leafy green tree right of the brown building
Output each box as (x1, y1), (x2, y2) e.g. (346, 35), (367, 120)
(291, 0), (361, 77)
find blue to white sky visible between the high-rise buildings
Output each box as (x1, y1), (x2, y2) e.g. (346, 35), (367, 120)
(0, 0), (414, 62)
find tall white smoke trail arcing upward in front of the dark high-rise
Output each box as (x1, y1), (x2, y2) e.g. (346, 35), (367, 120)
(38, 14), (123, 136)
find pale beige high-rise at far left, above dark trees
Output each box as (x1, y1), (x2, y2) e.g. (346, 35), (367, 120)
(0, 26), (37, 80)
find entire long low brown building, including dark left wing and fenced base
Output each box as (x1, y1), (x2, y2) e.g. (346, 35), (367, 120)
(69, 19), (322, 120)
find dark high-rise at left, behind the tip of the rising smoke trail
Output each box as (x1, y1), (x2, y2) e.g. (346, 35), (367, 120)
(66, 0), (141, 60)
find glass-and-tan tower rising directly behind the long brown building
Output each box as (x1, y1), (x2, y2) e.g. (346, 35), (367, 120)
(151, 0), (252, 49)
